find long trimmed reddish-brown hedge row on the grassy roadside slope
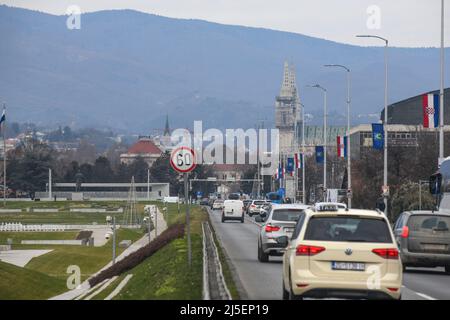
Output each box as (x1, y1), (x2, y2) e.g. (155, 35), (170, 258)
(89, 224), (184, 287)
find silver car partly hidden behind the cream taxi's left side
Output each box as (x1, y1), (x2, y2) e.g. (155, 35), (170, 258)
(255, 204), (309, 262)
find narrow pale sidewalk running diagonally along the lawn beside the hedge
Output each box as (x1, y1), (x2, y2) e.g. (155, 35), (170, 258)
(49, 209), (167, 300)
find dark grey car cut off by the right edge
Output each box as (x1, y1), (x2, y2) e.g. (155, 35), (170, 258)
(394, 211), (450, 274)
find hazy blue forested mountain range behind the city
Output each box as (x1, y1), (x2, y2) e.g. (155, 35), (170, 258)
(0, 6), (450, 134)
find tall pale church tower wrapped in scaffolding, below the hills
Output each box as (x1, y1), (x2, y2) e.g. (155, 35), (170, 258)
(275, 62), (302, 154)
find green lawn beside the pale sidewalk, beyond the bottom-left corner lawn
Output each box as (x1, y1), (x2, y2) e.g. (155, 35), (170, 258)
(25, 229), (144, 281)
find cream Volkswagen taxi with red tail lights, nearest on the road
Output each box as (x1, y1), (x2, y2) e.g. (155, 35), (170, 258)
(277, 205), (403, 300)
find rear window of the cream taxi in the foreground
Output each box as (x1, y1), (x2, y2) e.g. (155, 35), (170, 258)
(305, 217), (392, 243)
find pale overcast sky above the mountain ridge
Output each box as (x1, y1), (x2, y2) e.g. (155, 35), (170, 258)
(0, 0), (450, 47)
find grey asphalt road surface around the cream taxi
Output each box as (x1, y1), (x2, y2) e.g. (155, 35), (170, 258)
(208, 209), (450, 300)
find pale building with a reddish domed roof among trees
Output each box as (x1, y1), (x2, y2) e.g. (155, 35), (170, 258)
(120, 136), (162, 167)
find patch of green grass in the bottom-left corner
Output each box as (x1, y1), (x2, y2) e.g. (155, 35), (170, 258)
(0, 261), (67, 300)
